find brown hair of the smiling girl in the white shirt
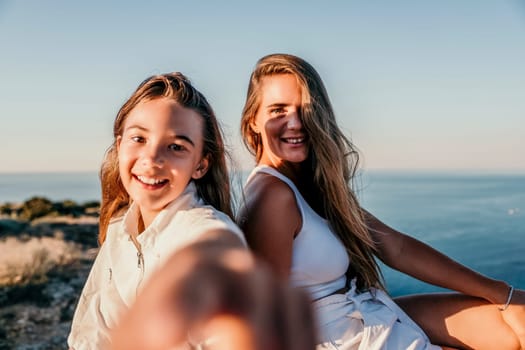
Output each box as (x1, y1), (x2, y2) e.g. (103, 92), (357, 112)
(98, 72), (233, 244)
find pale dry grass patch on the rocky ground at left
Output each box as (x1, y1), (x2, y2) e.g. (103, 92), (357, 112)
(0, 234), (81, 287)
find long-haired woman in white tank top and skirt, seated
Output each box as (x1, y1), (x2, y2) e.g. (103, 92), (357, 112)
(239, 54), (525, 349)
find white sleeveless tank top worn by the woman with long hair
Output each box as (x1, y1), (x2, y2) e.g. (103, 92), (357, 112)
(247, 165), (350, 300)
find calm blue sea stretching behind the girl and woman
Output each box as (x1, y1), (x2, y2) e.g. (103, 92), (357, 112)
(0, 171), (525, 296)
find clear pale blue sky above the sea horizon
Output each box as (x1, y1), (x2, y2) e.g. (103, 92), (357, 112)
(0, 0), (525, 173)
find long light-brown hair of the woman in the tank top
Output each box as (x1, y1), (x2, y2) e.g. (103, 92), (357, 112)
(241, 54), (383, 289)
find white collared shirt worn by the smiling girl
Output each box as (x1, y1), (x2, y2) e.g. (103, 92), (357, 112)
(68, 183), (246, 349)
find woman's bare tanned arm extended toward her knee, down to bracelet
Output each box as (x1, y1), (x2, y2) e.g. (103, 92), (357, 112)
(365, 212), (510, 305)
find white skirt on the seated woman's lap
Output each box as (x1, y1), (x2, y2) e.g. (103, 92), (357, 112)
(312, 280), (441, 350)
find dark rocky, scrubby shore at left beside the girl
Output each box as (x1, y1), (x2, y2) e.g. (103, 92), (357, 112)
(0, 198), (98, 350)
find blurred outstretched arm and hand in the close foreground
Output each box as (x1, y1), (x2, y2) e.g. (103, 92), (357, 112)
(112, 241), (315, 350)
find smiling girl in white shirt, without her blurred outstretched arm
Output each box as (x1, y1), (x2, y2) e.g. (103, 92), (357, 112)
(68, 73), (245, 349)
